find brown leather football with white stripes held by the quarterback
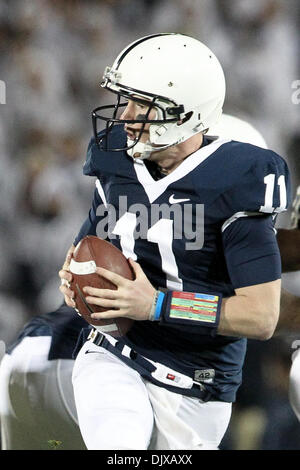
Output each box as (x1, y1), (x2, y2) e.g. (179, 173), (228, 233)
(69, 235), (134, 337)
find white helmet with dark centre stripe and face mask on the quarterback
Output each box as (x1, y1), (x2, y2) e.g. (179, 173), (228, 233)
(92, 33), (226, 158)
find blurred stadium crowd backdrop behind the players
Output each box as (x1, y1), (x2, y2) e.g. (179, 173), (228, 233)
(0, 0), (300, 450)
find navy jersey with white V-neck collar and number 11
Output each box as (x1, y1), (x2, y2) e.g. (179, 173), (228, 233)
(75, 126), (290, 401)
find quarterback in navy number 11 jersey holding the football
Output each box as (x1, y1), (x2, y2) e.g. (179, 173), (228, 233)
(60, 34), (290, 449)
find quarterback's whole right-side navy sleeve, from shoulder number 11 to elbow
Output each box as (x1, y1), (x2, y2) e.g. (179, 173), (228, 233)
(220, 147), (291, 289)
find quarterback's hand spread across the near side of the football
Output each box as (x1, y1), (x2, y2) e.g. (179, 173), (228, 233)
(83, 258), (156, 320)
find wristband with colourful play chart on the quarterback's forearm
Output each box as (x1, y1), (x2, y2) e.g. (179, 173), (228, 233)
(161, 291), (222, 335)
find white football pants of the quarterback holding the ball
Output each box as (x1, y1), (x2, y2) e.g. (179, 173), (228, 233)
(73, 341), (231, 450)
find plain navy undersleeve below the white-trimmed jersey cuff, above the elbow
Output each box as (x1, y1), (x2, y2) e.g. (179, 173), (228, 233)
(222, 214), (281, 289)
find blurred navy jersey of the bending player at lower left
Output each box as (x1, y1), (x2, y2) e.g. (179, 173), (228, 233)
(7, 304), (88, 360)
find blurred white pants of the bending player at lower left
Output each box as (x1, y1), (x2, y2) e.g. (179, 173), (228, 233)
(0, 336), (85, 450)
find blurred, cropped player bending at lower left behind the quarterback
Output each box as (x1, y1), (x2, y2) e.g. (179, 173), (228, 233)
(0, 305), (87, 450)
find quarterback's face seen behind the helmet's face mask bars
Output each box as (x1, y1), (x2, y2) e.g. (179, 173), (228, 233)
(120, 100), (156, 143)
